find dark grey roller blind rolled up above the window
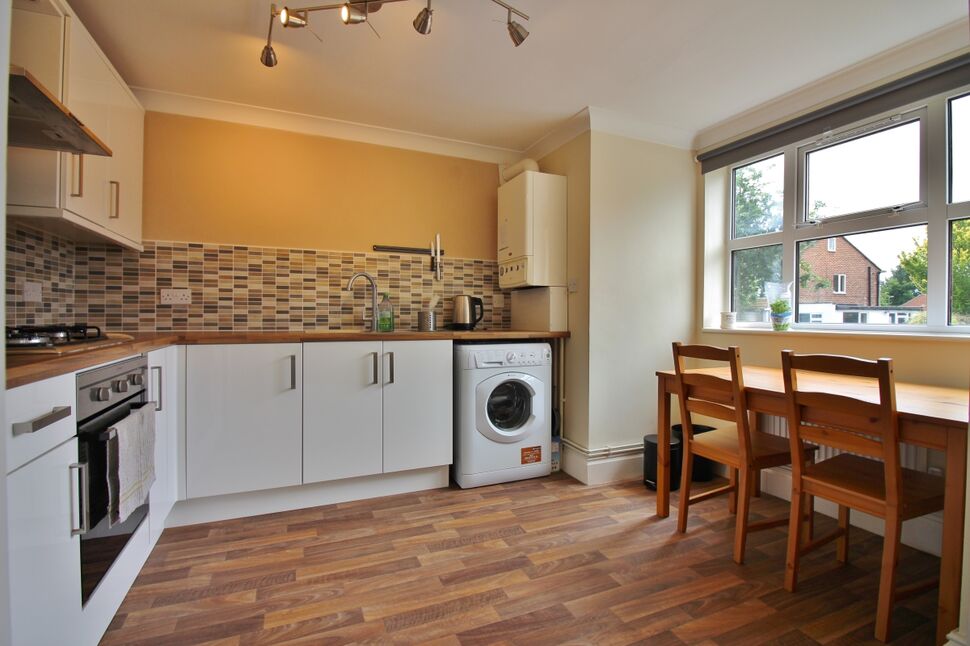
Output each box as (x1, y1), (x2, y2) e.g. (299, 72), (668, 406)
(697, 54), (970, 173)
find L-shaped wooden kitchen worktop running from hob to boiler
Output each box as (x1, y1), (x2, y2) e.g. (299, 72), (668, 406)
(7, 330), (569, 388)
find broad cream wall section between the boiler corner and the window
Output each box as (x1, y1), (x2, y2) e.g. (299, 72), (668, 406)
(589, 131), (697, 449)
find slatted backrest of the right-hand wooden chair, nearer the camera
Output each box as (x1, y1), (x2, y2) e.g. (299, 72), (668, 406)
(781, 350), (901, 505)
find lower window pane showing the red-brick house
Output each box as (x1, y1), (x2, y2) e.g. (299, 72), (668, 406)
(797, 224), (927, 325)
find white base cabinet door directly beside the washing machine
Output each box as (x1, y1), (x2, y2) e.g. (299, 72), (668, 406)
(384, 341), (454, 473)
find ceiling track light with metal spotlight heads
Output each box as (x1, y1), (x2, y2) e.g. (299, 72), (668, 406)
(259, 0), (529, 67)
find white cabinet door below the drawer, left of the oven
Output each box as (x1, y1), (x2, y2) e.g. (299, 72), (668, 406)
(4, 438), (81, 644)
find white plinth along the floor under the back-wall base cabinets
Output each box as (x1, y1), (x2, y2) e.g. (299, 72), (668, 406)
(165, 466), (448, 527)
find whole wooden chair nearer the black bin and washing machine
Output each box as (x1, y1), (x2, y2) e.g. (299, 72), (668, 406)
(673, 342), (812, 564)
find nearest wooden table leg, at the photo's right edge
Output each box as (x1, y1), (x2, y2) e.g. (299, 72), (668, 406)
(936, 428), (967, 644)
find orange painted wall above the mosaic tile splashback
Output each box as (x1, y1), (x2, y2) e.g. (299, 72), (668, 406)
(144, 112), (498, 260)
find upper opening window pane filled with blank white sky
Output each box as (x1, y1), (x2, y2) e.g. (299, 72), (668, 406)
(806, 121), (920, 220)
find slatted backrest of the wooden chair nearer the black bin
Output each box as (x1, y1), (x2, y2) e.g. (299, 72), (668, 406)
(673, 342), (753, 463)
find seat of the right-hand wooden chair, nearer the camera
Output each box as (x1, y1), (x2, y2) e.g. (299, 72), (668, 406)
(803, 453), (944, 519)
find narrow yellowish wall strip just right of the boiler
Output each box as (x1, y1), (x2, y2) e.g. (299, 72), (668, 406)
(539, 131), (590, 447)
